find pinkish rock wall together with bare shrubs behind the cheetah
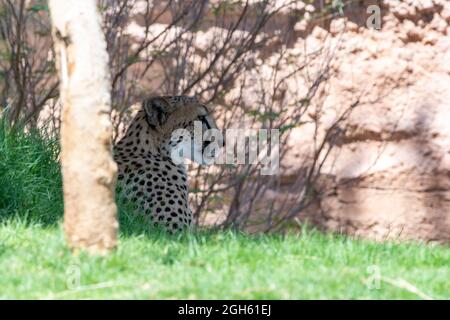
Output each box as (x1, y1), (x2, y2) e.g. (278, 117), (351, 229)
(0, 0), (450, 242)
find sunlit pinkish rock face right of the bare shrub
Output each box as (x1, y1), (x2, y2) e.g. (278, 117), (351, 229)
(284, 0), (450, 242)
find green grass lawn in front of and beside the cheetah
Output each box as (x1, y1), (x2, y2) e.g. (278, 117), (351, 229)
(0, 119), (450, 299)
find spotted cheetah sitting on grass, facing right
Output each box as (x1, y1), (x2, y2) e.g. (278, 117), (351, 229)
(113, 96), (223, 233)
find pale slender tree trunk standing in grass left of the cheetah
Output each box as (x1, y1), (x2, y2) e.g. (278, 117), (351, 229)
(49, 0), (118, 254)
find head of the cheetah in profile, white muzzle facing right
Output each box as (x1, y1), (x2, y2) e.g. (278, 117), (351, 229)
(143, 96), (223, 164)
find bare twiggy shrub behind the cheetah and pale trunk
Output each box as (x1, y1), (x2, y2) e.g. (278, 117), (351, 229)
(0, 0), (357, 234)
